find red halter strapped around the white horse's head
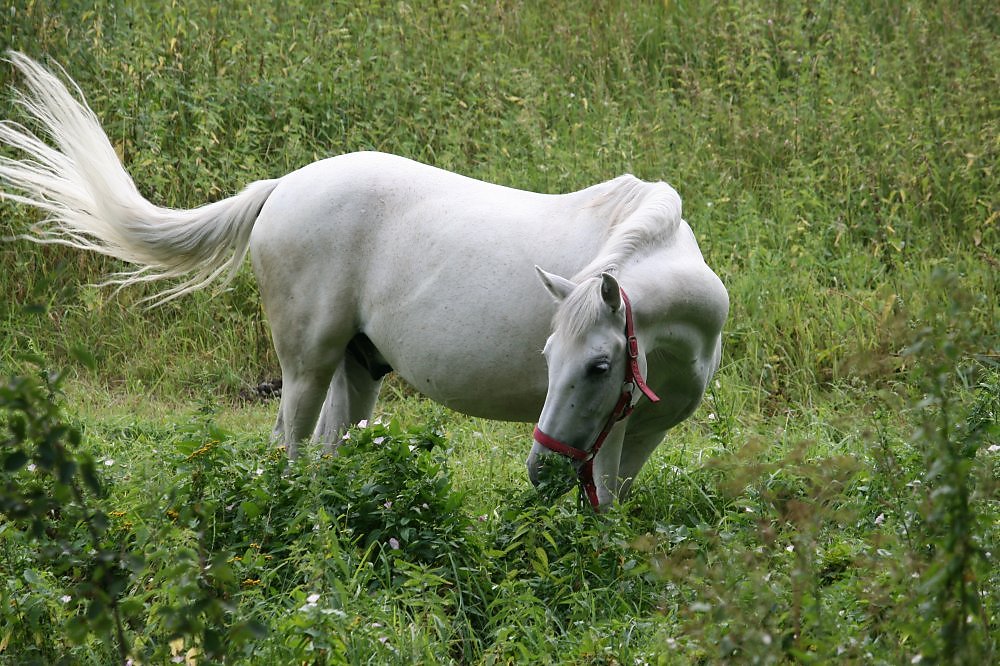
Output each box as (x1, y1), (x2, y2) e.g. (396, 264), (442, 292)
(535, 289), (660, 509)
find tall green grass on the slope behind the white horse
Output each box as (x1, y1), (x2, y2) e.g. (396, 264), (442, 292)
(0, 2), (1000, 396)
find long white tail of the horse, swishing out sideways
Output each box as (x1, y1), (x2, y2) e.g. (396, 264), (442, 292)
(0, 51), (279, 304)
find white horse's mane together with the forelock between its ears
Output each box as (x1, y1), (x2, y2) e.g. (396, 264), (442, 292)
(552, 174), (681, 337)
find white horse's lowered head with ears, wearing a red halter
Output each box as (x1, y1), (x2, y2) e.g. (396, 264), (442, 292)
(527, 268), (659, 508)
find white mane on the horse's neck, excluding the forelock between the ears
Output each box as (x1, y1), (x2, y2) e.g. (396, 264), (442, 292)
(573, 174), (682, 282)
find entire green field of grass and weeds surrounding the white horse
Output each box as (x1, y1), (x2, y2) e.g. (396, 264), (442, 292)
(0, 0), (1000, 664)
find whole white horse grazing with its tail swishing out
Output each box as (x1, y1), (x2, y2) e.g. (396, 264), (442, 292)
(0, 52), (729, 505)
